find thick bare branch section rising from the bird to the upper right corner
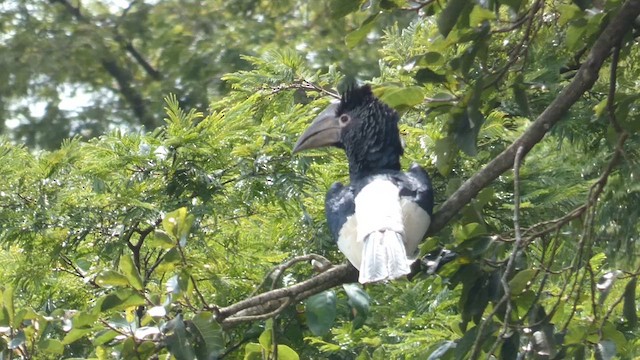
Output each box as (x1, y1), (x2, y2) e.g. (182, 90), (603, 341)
(427, 0), (640, 236)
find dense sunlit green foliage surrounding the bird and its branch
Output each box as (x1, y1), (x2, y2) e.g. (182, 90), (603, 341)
(0, 0), (640, 359)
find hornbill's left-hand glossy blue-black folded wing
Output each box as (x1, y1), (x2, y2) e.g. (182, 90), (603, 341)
(324, 182), (356, 242)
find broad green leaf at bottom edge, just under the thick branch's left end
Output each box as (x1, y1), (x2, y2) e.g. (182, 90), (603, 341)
(189, 311), (225, 359)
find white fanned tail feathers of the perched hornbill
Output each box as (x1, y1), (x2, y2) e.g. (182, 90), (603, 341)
(358, 230), (411, 284)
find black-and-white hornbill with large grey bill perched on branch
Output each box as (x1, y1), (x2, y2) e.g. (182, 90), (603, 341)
(293, 85), (433, 284)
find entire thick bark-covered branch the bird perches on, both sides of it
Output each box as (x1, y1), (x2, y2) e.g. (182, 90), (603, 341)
(216, 0), (640, 327)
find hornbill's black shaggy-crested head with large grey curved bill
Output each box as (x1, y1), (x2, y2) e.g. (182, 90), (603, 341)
(293, 85), (403, 179)
